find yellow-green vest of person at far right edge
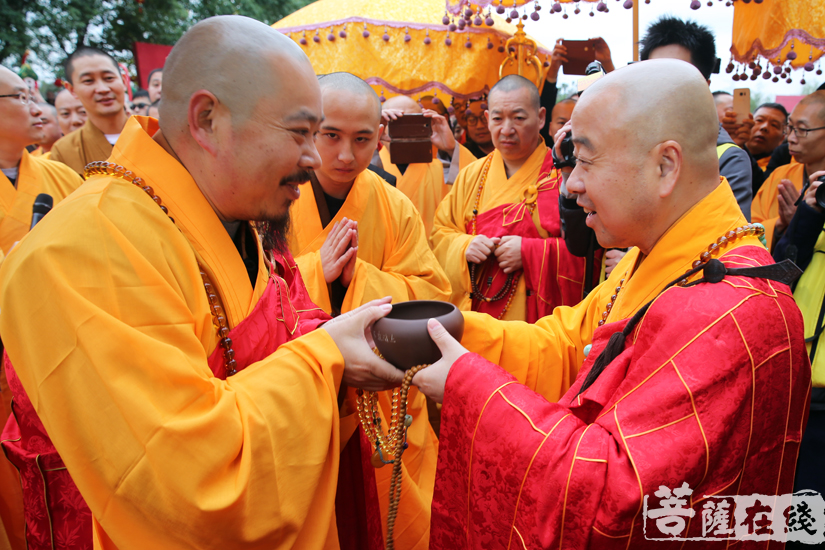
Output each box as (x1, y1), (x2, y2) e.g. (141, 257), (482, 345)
(793, 232), (825, 387)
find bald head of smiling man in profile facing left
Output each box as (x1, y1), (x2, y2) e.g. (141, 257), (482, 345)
(567, 59), (720, 254)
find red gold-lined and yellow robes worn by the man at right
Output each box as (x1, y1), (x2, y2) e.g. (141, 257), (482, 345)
(430, 181), (811, 550)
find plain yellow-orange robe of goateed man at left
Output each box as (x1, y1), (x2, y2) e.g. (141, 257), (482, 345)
(0, 117), (344, 550)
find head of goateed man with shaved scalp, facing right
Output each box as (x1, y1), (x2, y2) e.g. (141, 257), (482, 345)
(153, 15), (323, 235)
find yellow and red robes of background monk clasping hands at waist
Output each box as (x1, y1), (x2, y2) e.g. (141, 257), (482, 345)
(430, 142), (601, 322)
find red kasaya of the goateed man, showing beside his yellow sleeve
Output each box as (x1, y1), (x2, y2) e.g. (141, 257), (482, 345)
(0, 252), (332, 550)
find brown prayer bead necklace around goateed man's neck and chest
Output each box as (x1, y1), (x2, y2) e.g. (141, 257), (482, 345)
(85, 161), (238, 378)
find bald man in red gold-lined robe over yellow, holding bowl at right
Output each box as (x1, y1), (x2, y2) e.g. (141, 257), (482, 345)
(414, 60), (811, 550)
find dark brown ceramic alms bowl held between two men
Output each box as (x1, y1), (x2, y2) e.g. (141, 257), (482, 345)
(372, 300), (464, 370)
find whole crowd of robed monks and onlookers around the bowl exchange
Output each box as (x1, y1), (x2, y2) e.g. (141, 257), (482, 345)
(0, 9), (825, 550)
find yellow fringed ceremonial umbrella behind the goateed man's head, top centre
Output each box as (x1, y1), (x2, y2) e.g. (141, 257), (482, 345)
(273, 0), (551, 103)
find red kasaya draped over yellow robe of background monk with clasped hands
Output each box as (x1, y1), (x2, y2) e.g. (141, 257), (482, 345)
(466, 150), (601, 323)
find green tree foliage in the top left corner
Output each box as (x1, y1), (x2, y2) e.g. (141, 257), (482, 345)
(0, 0), (311, 75)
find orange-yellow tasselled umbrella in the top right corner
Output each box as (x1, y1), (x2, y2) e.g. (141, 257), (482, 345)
(727, 0), (825, 84)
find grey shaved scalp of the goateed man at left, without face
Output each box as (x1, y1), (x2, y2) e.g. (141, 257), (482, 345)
(160, 16), (311, 136)
